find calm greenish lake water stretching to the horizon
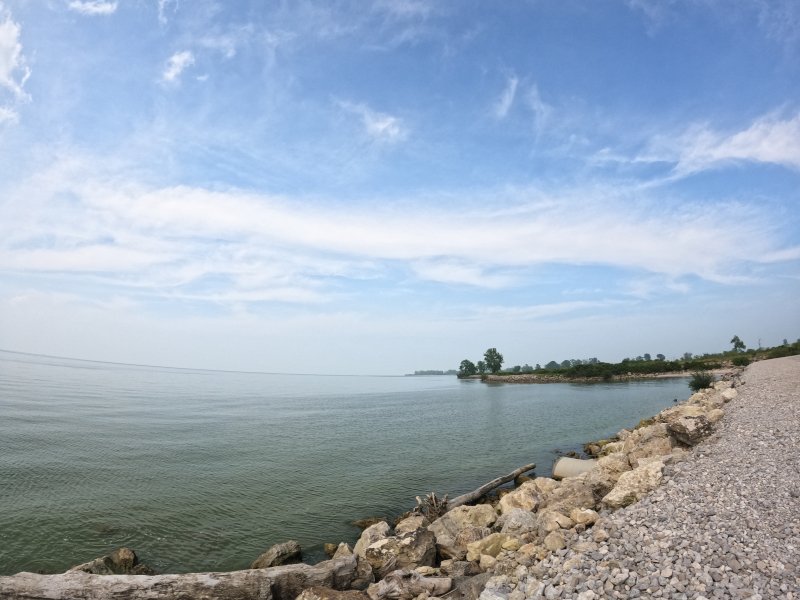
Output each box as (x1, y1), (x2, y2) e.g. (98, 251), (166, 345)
(0, 352), (689, 575)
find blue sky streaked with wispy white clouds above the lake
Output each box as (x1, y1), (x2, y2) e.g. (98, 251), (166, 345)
(0, 0), (800, 374)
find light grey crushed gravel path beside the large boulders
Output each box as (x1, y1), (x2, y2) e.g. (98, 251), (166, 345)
(498, 356), (800, 600)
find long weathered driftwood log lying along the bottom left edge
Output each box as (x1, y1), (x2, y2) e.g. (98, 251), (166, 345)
(0, 556), (356, 600)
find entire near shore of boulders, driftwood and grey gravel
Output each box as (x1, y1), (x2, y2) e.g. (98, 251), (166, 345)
(0, 357), (800, 600)
